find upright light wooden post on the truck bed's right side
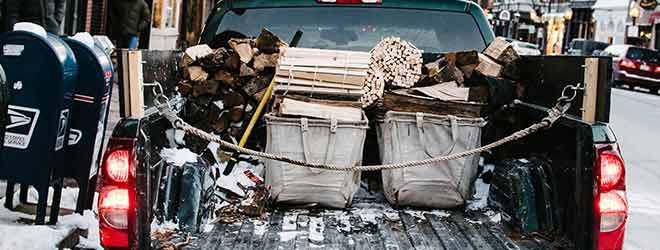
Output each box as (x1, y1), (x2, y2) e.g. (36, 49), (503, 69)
(582, 58), (608, 123)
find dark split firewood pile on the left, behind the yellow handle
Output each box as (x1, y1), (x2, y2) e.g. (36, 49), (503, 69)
(178, 29), (287, 153)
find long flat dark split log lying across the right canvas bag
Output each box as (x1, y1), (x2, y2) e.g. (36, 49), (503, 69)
(383, 92), (486, 118)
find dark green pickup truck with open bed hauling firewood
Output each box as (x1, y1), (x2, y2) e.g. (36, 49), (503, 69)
(97, 0), (627, 249)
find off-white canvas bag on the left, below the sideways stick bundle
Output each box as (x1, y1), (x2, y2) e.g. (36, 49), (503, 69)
(265, 115), (368, 208)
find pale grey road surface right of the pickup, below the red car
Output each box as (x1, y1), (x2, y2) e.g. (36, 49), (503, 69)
(610, 89), (660, 250)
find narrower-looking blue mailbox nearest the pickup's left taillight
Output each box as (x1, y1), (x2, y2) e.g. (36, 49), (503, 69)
(56, 33), (113, 214)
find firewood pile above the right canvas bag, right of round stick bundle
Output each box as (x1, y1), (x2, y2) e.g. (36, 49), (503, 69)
(377, 38), (520, 117)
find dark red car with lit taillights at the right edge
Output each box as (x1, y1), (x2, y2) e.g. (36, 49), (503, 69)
(602, 45), (660, 93)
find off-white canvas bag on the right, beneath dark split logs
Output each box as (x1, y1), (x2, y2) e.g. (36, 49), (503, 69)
(378, 111), (486, 208)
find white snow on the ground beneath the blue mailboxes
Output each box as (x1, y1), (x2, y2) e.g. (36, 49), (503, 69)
(0, 188), (102, 250)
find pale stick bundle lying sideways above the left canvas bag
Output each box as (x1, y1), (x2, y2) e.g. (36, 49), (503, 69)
(275, 48), (370, 101)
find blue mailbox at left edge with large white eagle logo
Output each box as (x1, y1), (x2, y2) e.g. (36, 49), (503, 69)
(0, 24), (78, 224)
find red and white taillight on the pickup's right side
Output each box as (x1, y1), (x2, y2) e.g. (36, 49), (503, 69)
(594, 144), (628, 250)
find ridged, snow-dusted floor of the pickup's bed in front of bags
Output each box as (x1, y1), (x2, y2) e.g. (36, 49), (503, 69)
(185, 190), (553, 250)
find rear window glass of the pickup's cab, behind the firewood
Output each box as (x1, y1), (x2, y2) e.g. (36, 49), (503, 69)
(210, 7), (486, 53)
